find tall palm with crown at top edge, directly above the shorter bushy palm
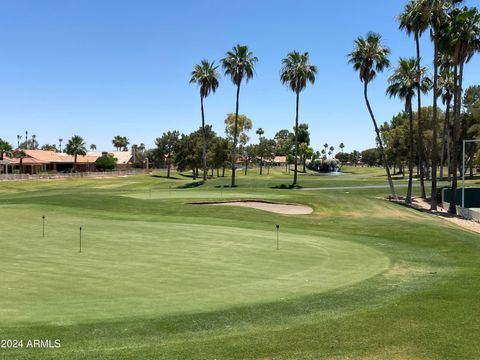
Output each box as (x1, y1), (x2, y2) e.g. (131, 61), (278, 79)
(398, 0), (436, 198)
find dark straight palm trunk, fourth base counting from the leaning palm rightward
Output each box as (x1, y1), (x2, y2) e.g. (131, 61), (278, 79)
(432, 32), (443, 210)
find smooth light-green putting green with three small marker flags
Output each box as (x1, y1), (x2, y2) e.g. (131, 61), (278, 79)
(0, 205), (389, 325)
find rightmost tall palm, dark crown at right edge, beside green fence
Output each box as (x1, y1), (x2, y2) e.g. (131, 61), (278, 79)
(447, 7), (480, 214)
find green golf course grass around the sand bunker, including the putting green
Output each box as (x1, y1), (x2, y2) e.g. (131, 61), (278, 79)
(0, 168), (480, 359)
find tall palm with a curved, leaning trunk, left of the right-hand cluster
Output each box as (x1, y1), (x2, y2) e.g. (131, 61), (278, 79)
(348, 33), (397, 198)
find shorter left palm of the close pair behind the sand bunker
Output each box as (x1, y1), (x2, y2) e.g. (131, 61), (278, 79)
(190, 60), (218, 180)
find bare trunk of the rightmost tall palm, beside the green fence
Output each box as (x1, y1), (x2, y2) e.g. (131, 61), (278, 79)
(448, 63), (463, 214)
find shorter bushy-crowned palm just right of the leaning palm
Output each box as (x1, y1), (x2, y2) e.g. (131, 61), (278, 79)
(387, 58), (432, 204)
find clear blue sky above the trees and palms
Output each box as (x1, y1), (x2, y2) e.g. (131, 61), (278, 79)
(0, 0), (480, 151)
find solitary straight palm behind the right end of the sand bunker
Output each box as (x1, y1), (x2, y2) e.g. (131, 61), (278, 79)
(280, 51), (317, 185)
